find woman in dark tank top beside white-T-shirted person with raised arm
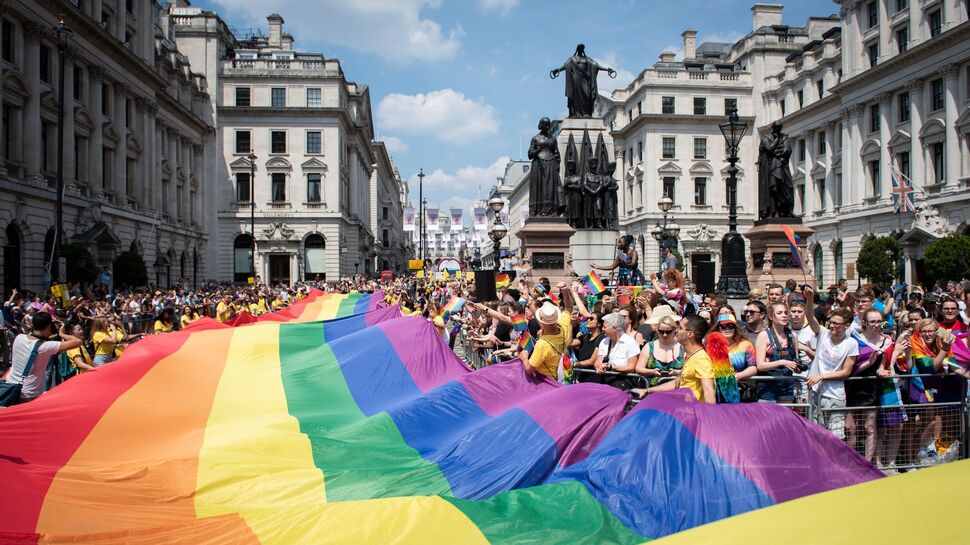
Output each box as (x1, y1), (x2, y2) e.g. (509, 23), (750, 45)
(748, 303), (799, 403)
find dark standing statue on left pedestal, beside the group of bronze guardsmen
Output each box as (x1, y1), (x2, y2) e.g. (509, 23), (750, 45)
(529, 117), (565, 217)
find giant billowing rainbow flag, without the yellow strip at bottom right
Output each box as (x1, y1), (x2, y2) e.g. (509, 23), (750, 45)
(0, 286), (908, 545)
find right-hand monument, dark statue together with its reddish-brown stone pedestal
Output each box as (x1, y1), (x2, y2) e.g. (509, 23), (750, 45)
(744, 121), (815, 288)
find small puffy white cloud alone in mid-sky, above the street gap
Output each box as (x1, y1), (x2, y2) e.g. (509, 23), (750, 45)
(377, 89), (499, 144)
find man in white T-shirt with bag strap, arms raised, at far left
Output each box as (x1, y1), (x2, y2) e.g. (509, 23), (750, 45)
(6, 311), (81, 403)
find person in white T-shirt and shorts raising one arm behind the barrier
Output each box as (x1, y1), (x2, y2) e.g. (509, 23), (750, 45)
(804, 288), (859, 439)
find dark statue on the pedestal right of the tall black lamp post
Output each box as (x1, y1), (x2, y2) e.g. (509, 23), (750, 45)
(758, 121), (795, 219)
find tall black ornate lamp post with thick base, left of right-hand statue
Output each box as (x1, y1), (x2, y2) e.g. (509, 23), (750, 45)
(717, 108), (749, 299)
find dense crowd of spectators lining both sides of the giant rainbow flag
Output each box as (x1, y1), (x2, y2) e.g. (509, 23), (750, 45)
(0, 237), (970, 472)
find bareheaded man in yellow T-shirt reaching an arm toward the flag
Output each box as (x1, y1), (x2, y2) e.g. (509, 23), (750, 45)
(631, 316), (717, 403)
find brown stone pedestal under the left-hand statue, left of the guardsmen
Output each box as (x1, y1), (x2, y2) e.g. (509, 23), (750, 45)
(516, 218), (576, 285)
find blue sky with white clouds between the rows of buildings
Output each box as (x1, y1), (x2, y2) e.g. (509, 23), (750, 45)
(193, 0), (838, 216)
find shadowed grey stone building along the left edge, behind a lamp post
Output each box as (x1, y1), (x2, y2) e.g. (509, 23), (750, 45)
(0, 0), (215, 293)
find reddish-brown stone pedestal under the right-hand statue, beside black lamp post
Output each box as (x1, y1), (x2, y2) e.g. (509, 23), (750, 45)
(744, 218), (815, 291)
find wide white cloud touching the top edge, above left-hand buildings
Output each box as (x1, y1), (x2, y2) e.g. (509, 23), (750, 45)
(207, 0), (465, 64)
